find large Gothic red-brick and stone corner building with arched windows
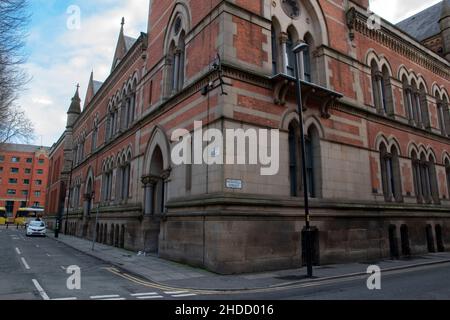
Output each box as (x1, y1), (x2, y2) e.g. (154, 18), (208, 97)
(48, 0), (450, 274)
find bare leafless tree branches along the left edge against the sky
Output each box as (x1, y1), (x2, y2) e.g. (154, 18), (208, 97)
(0, 0), (33, 143)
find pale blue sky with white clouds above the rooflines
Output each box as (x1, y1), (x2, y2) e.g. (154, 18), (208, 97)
(19, 0), (440, 146)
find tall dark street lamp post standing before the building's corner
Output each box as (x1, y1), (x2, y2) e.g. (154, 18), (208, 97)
(293, 42), (313, 278)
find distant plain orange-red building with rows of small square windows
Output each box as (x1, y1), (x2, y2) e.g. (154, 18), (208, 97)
(0, 144), (49, 216)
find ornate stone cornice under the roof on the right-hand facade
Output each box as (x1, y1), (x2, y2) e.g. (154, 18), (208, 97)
(347, 7), (450, 80)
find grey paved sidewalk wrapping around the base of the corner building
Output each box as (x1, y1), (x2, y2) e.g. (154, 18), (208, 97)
(49, 233), (450, 291)
